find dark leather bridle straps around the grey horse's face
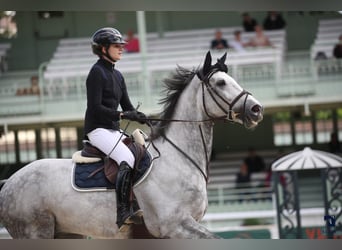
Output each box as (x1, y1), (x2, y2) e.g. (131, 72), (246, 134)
(197, 69), (251, 121)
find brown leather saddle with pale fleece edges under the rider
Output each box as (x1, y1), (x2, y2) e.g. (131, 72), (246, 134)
(73, 129), (146, 184)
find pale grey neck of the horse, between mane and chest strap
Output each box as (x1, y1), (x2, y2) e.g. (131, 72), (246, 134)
(165, 82), (213, 167)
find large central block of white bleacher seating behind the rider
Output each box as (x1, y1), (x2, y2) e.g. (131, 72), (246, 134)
(44, 27), (286, 89)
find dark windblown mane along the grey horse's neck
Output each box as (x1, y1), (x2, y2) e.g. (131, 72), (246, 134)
(152, 66), (198, 139)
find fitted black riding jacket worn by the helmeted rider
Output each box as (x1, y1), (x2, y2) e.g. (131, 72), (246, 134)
(84, 59), (134, 137)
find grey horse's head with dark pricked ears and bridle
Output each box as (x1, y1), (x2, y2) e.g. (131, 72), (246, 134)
(197, 52), (263, 128)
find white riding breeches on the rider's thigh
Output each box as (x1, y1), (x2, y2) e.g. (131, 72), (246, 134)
(87, 128), (134, 168)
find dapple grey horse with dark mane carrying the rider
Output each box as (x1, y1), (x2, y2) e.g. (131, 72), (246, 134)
(0, 52), (263, 238)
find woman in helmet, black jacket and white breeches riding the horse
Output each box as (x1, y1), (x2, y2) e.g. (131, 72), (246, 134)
(84, 27), (146, 228)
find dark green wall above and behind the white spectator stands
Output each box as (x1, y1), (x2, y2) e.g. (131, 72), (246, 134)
(0, 11), (342, 70)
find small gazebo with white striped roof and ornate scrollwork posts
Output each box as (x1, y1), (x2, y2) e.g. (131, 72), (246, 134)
(272, 147), (342, 238)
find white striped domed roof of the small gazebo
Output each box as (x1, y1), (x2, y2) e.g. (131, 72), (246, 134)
(272, 147), (342, 171)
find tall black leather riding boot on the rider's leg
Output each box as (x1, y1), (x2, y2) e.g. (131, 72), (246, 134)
(116, 161), (133, 229)
